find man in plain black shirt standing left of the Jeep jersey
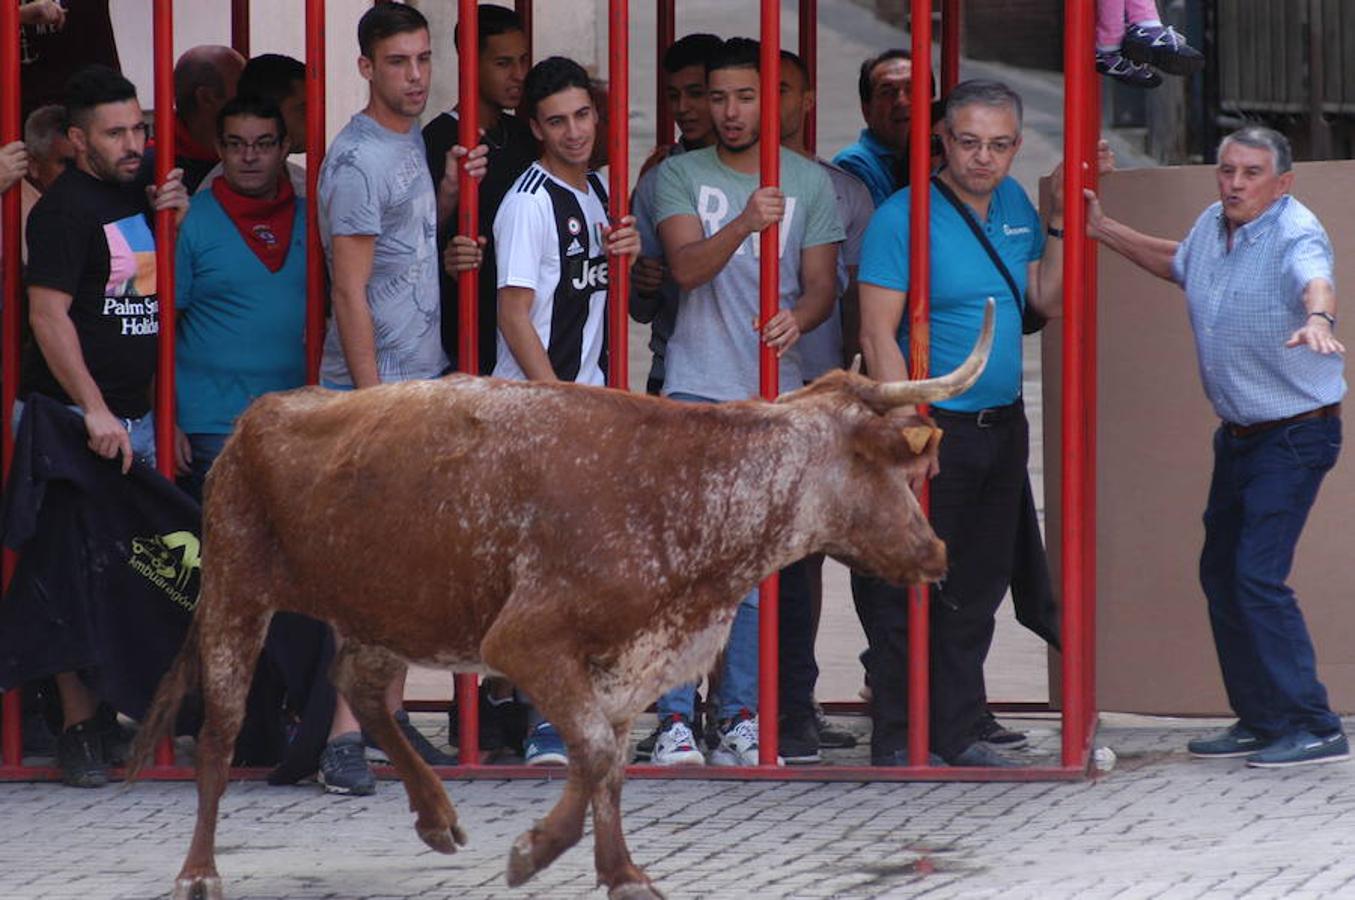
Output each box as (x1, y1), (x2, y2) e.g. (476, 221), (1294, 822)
(423, 5), (538, 375)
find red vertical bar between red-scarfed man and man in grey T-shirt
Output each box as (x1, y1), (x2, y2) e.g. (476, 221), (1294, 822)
(306, 0), (325, 384)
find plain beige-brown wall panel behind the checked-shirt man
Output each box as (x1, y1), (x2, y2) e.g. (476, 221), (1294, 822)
(1045, 161), (1355, 714)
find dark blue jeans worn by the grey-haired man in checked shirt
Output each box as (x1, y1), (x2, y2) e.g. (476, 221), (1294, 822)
(1199, 417), (1341, 737)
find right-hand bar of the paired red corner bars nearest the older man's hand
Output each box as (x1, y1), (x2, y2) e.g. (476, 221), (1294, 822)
(1080, 76), (1102, 745)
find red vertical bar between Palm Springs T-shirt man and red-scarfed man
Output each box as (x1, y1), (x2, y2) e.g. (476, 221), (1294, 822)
(153, 0), (175, 766)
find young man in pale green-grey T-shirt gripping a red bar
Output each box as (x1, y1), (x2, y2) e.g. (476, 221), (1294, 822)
(654, 38), (844, 766)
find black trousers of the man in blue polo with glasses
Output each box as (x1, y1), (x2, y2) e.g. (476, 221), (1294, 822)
(852, 403), (1028, 762)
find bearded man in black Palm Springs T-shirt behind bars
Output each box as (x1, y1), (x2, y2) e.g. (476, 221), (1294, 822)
(20, 65), (188, 788)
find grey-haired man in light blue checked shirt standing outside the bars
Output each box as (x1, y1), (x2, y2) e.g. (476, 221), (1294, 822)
(1087, 126), (1350, 767)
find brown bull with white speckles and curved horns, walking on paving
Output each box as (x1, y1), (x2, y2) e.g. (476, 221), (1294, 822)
(133, 308), (992, 899)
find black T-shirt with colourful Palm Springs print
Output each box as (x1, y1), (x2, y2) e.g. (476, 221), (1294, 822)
(20, 167), (160, 419)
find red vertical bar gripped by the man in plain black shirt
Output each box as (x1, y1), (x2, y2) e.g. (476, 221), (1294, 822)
(455, 0), (482, 766)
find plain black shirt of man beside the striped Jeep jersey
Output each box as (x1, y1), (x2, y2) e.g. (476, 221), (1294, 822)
(423, 113), (541, 375)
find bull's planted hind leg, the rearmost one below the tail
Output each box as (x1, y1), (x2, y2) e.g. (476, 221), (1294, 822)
(173, 601), (272, 900)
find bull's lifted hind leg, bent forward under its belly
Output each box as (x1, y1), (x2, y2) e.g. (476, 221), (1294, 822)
(335, 640), (466, 853)
